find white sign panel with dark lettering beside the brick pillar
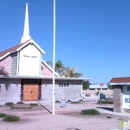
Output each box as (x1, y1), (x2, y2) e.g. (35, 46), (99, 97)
(123, 85), (130, 109)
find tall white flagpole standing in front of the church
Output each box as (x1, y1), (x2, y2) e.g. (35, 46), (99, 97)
(52, 0), (56, 115)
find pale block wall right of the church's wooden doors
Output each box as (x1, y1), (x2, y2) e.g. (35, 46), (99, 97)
(42, 80), (81, 101)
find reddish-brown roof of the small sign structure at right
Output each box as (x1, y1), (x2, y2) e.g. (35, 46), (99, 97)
(110, 77), (130, 83)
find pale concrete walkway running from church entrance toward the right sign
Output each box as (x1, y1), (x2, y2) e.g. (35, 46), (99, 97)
(40, 101), (130, 117)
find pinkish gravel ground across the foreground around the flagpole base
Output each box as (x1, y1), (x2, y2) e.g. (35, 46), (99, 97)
(0, 105), (130, 130)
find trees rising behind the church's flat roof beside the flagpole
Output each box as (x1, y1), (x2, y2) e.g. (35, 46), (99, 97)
(47, 60), (83, 78)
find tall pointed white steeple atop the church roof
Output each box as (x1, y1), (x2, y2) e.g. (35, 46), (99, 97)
(21, 3), (31, 43)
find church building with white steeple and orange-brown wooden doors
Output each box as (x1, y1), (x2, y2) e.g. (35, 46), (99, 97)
(0, 4), (90, 105)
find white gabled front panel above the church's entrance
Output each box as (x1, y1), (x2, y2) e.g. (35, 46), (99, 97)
(19, 43), (41, 76)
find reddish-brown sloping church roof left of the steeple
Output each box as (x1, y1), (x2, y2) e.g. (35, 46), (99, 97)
(0, 40), (29, 57)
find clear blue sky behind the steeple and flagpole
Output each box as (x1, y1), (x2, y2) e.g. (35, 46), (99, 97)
(0, 0), (130, 83)
